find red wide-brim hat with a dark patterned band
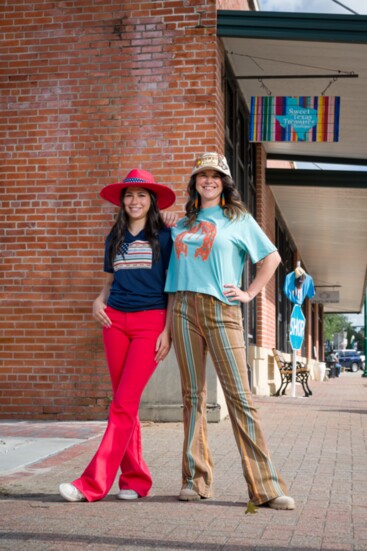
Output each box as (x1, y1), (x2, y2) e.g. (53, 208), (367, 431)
(100, 168), (176, 210)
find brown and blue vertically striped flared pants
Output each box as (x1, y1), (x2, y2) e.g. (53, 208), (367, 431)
(173, 291), (288, 505)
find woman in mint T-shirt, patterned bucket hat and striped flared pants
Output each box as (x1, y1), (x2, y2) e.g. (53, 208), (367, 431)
(165, 153), (295, 509)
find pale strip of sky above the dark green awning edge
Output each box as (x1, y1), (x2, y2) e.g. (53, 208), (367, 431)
(258, 0), (367, 15)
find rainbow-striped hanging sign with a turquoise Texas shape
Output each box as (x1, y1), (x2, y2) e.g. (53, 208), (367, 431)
(250, 96), (340, 142)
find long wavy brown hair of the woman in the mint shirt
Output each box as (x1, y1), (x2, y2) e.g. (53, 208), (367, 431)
(185, 172), (247, 228)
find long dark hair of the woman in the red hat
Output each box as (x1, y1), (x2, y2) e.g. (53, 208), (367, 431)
(109, 188), (165, 266)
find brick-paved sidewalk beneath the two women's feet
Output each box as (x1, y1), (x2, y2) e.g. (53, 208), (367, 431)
(0, 372), (367, 551)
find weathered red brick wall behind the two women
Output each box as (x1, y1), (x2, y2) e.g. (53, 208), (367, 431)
(0, 0), (226, 419)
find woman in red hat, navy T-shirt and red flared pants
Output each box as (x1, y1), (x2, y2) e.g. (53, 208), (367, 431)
(59, 169), (176, 501)
